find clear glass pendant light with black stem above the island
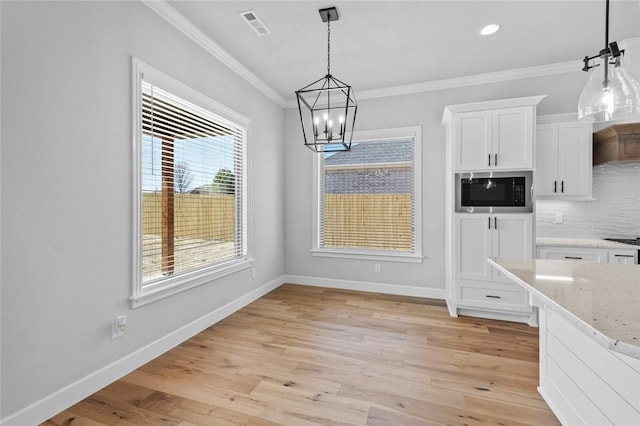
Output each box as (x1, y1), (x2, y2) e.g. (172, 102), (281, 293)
(578, 0), (640, 122)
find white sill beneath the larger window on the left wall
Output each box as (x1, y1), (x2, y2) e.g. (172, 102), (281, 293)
(130, 259), (254, 309)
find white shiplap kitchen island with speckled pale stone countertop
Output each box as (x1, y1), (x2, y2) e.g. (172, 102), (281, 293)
(489, 258), (640, 425)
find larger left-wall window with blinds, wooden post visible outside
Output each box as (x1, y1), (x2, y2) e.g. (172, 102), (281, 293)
(132, 60), (249, 306)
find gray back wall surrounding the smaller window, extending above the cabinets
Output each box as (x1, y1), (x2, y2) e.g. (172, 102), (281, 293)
(285, 69), (586, 289)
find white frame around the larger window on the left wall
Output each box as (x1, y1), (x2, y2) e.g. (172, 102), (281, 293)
(130, 57), (253, 308)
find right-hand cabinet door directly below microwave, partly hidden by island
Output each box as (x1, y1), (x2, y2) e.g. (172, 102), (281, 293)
(492, 214), (533, 282)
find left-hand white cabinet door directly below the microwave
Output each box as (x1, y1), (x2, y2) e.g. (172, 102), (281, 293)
(454, 214), (493, 281)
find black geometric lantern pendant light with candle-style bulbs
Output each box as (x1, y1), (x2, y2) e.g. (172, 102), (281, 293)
(296, 7), (358, 152)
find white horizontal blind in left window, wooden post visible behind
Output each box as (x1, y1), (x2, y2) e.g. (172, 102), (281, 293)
(140, 80), (246, 286)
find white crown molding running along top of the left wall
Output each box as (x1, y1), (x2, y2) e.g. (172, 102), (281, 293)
(140, 0), (288, 108)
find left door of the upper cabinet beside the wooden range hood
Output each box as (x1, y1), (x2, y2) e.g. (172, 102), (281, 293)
(535, 124), (558, 196)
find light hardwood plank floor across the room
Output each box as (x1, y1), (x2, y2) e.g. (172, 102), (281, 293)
(43, 284), (559, 426)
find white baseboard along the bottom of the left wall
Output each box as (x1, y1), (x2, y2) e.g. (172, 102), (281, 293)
(0, 276), (286, 426)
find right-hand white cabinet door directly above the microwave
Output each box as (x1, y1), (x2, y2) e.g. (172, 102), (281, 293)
(490, 107), (534, 169)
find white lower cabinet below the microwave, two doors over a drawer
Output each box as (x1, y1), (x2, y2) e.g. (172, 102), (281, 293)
(448, 213), (537, 325)
